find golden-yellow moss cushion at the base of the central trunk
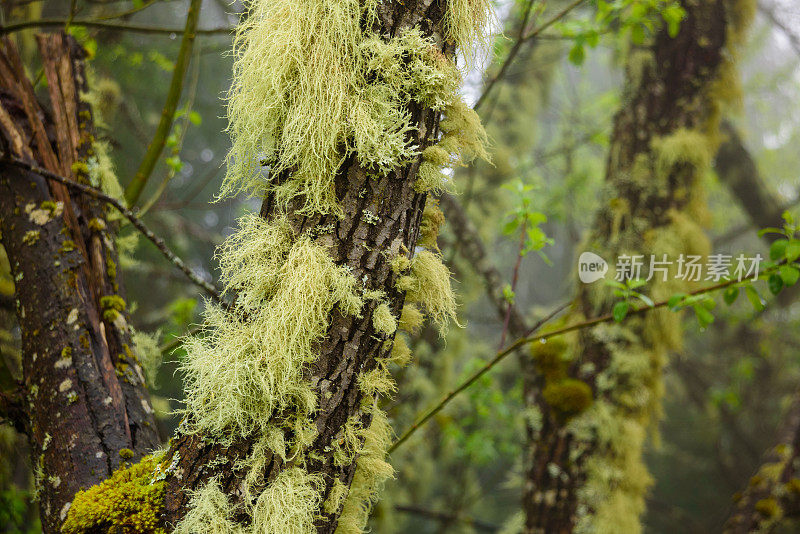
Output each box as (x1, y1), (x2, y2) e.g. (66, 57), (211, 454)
(61, 456), (167, 534)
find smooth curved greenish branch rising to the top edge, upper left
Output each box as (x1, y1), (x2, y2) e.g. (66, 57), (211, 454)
(125, 0), (203, 206)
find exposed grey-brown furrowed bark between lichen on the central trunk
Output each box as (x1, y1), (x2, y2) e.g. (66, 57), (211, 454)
(159, 0), (453, 533)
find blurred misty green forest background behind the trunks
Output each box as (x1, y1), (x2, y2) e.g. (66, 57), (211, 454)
(0, 0), (800, 534)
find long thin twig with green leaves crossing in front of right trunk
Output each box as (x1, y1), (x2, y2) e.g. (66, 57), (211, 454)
(388, 272), (784, 453)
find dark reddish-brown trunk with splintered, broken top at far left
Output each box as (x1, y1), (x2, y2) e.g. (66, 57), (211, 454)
(0, 34), (159, 532)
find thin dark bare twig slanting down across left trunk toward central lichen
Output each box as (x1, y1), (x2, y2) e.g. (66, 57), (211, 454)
(5, 157), (227, 307)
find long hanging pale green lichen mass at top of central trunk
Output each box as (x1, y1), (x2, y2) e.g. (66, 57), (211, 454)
(221, 0), (458, 213)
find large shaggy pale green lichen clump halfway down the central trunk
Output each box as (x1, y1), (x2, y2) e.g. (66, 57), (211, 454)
(183, 215), (362, 442)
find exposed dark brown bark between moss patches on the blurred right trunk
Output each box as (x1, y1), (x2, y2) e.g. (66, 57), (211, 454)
(524, 0), (728, 534)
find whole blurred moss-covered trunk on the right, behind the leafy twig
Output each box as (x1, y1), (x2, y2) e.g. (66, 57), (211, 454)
(524, 0), (741, 533)
